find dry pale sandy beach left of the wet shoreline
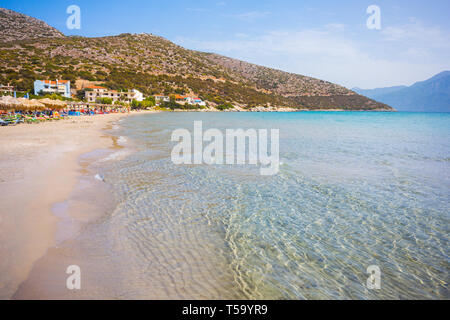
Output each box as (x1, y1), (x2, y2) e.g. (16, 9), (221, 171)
(0, 113), (148, 299)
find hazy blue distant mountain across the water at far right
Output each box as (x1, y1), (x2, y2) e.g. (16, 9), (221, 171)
(352, 71), (450, 112)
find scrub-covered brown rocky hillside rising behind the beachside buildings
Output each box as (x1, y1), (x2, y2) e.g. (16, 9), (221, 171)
(0, 7), (392, 110)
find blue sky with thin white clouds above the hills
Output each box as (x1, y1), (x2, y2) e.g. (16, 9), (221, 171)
(0, 0), (450, 88)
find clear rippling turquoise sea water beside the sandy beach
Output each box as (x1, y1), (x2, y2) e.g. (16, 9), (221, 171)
(91, 112), (450, 299)
